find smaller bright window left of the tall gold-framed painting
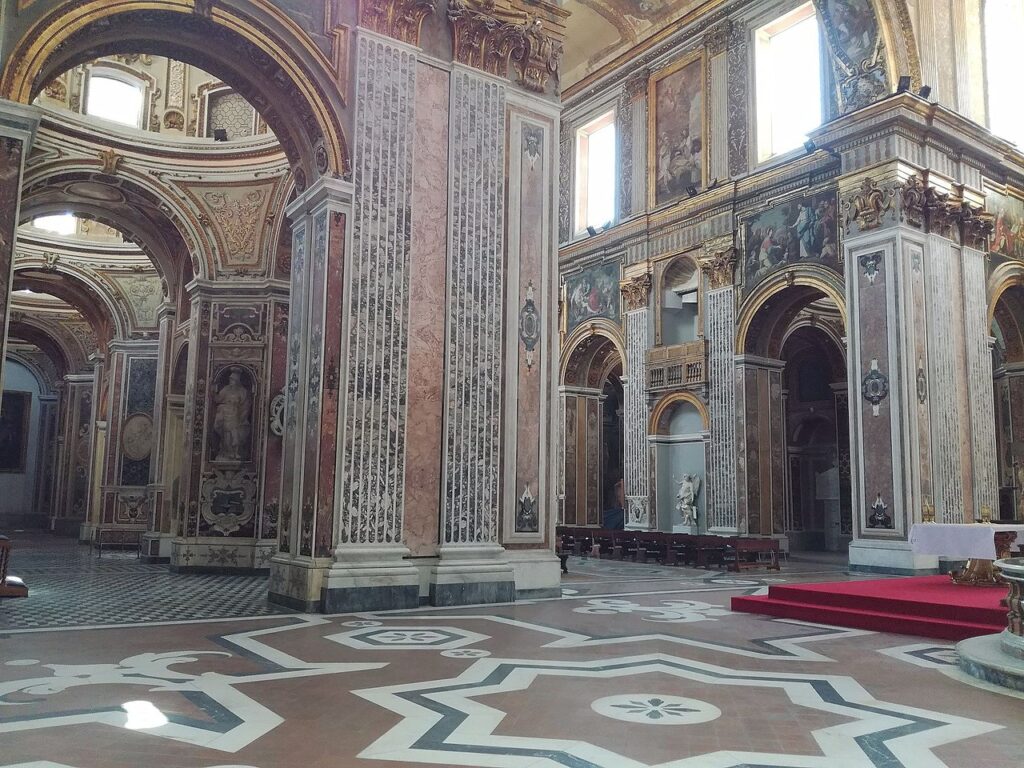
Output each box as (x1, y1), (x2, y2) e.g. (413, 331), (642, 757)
(575, 112), (615, 232)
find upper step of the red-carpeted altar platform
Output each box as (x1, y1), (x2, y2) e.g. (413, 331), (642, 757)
(768, 577), (1007, 628)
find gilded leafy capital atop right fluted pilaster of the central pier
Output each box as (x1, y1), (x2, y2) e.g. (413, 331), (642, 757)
(446, 0), (562, 93)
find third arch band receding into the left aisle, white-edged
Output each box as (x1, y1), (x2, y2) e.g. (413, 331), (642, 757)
(11, 268), (130, 345)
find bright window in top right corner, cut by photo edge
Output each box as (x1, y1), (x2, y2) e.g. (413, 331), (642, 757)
(985, 0), (1024, 147)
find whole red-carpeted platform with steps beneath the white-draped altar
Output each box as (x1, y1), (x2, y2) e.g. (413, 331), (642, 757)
(732, 575), (1008, 640)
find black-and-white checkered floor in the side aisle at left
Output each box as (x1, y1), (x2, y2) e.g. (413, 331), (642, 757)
(0, 534), (291, 633)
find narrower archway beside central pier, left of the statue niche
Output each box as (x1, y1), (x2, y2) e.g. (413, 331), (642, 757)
(560, 323), (624, 527)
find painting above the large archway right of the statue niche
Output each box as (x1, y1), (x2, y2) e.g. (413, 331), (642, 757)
(743, 189), (843, 292)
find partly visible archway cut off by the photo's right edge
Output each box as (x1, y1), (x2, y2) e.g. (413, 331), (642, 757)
(989, 263), (1024, 520)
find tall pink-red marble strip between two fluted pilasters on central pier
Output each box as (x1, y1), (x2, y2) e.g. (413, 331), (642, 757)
(402, 63), (449, 555)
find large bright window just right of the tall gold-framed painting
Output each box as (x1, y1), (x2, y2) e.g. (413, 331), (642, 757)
(754, 3), (821, 163)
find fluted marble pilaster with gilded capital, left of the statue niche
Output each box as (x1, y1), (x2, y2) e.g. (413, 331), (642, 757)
(622, 271), (657, 530)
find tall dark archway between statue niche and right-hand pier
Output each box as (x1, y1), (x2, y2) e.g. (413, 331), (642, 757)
(736, 280), (852, 550)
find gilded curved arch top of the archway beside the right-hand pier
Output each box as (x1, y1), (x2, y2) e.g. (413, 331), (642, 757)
(736, 265), (849, 356)
